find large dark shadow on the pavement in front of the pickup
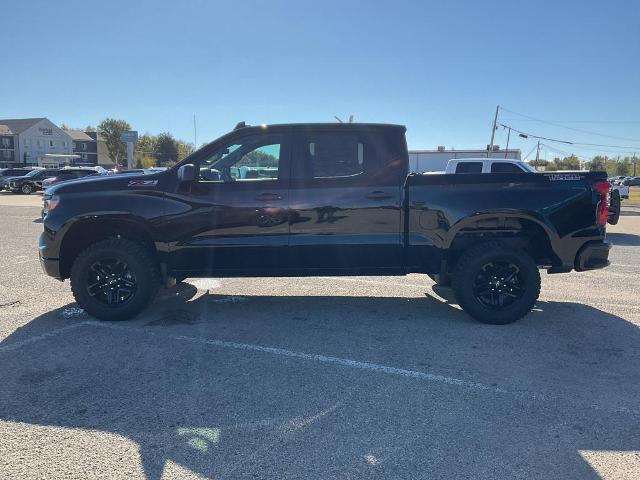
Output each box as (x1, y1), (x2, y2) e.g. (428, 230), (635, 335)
(0, 285), (640, 480)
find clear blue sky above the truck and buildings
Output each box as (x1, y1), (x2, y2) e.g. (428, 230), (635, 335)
(5, 0), (640, 157)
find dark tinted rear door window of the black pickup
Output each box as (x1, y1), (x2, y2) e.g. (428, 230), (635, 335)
(304, 133), (367, 178)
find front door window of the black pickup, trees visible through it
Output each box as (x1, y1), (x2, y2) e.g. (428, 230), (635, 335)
(199, 135), (282, 182)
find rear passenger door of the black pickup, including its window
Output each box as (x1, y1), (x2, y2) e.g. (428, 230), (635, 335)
(288, 126), (407, 271)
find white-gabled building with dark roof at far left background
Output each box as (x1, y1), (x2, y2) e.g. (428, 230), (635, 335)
(0, 118), (78, 167)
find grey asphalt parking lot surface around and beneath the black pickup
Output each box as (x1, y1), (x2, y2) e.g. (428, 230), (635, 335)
(0, 193), (640, 480)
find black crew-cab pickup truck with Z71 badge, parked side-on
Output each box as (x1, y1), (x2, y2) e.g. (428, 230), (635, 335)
(39, 124), (610, 324)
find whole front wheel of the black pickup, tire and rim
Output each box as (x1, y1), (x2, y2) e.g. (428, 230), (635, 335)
(71, 238), (160, 320)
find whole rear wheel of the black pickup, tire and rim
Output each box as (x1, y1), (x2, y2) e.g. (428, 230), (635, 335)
(453, 242), (540, 325)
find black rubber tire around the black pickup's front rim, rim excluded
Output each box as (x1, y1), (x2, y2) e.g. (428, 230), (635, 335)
(71, 238), (160, 320)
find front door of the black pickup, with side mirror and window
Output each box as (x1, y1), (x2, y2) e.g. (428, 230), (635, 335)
(165, 130), (291, 275)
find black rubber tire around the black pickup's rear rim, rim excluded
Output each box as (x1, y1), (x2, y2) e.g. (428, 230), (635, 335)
(452, 242), (540, 325)
